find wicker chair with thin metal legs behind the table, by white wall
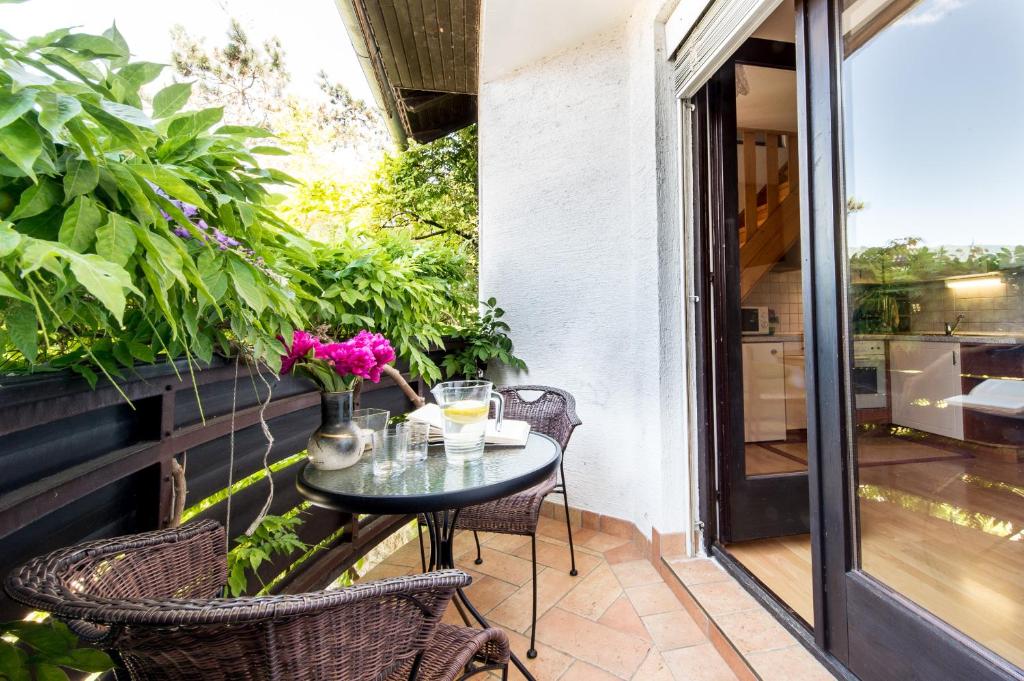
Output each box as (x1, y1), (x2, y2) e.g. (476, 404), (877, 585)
(420, 385), (582, 657)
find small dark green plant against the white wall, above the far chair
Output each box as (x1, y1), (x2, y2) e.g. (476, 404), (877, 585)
(442, 298), (526, 379)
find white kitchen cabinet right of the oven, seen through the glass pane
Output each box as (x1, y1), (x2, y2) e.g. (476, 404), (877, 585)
(889, 341), (964, 439)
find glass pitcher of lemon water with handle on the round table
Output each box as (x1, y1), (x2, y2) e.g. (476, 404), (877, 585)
(430, 381), (505, 465)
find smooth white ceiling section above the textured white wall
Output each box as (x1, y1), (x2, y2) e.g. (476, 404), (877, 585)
(480, 0), (633, 83)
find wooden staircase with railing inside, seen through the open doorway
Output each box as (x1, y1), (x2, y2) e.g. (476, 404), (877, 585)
(738, 130), (800, 300)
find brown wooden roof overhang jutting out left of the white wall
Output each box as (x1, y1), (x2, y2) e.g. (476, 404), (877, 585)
(336, 0), (480, 145)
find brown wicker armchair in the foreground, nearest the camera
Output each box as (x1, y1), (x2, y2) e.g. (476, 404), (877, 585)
(6, 520), (509, 681)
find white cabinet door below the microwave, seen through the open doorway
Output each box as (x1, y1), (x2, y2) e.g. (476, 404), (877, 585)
(743, 343), (785, 442)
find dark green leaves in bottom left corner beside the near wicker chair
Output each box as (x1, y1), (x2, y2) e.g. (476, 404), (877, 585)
(0, 618), (114, 681)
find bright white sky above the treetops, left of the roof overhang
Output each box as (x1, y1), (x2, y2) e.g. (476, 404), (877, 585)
(0, 0), (373, 103)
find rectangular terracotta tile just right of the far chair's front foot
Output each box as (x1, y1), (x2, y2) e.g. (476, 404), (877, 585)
(537, 607), (650, 679)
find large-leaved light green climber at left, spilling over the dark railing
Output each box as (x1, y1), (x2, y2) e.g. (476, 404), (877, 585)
(0, 23), (313, 384)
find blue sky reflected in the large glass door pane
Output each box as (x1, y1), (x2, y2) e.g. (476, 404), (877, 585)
(843, 0), (1024, 251)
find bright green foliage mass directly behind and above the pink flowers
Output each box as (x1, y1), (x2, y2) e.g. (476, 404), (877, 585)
(306, 231), (474, 381)
